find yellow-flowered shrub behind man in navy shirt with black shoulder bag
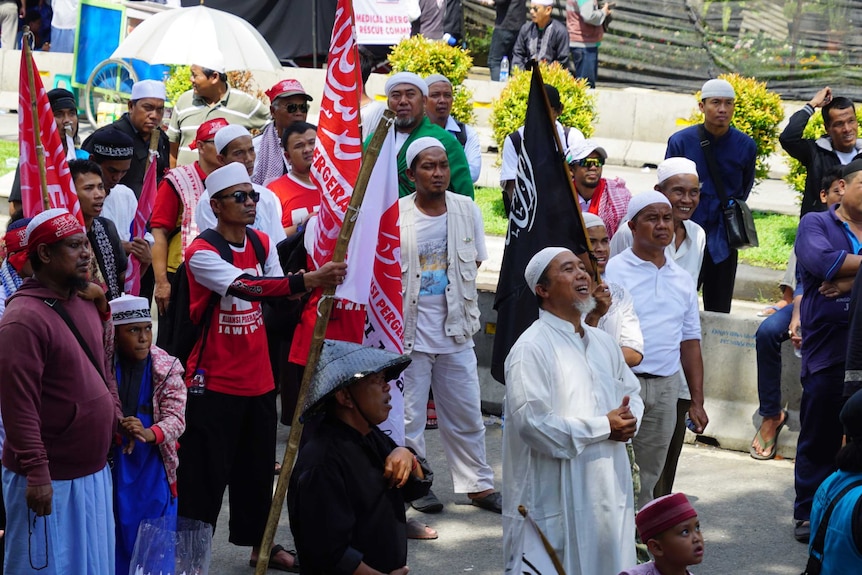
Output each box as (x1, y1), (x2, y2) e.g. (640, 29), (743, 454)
(689, 74), (784, 182)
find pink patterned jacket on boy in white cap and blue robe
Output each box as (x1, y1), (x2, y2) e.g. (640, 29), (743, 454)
(150, 345), (186, 497)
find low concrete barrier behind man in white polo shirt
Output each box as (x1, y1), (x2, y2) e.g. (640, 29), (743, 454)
(473, 290), (802, 458)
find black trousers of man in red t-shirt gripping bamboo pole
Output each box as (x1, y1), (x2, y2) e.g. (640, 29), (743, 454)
(177, 390), (276, 546)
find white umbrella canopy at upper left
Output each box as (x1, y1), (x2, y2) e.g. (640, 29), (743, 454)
(111, 6), (281, 72)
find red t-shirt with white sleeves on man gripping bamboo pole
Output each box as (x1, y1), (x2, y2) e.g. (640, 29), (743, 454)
(186, 230), (287, 396)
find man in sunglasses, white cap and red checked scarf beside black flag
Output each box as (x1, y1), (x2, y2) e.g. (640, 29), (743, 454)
(566, 140), (632, 239)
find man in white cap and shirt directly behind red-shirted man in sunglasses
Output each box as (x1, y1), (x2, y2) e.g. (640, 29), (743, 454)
(195, 124), (286, 244)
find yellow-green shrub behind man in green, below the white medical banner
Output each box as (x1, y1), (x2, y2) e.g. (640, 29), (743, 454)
(389, 36), (476, 124)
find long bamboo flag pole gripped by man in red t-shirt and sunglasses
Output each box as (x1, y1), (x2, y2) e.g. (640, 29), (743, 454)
(255, 110), (395, 575)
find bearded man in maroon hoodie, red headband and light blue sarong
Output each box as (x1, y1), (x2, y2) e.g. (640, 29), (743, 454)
(0, 209), (122, 575)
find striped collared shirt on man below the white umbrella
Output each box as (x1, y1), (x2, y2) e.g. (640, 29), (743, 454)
(168, 88), (269, 166)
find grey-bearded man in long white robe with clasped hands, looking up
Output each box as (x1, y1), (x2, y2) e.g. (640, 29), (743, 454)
(503, 248), (643, 575)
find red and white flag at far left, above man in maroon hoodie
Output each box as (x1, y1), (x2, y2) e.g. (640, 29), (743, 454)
(18, 50), (84, 225)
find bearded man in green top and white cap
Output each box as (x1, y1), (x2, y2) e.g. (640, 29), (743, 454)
(374, 72), (473, 198)
